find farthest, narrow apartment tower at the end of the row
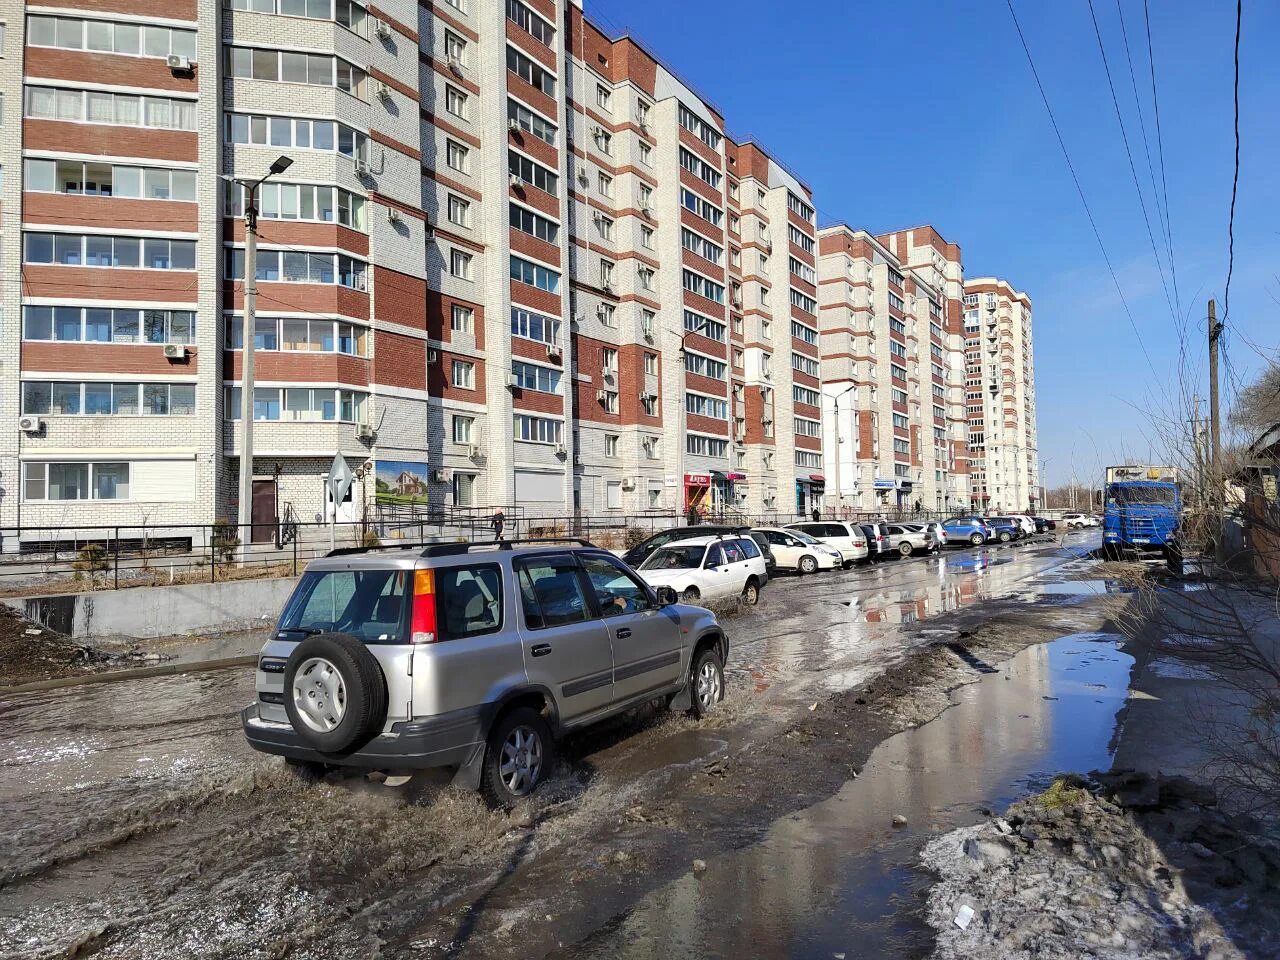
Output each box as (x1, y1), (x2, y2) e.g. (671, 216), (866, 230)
(964, 276), (1039, 512)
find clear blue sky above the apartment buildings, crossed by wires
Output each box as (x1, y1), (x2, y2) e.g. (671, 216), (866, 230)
(585, 0), (1280, 485)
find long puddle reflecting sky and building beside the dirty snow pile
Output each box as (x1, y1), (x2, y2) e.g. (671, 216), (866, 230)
(562, 634), (1133, 960)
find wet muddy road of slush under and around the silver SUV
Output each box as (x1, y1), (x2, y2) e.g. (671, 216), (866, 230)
(0, 535), (1115, 957)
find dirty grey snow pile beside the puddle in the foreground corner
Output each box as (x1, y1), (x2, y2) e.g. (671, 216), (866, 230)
(922, 773), (1280, 960)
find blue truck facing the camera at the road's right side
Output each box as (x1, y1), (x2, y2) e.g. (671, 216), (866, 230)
(1102, 465), (1183, 566)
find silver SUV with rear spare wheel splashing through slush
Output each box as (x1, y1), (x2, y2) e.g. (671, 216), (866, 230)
(241, 540), (728, 805)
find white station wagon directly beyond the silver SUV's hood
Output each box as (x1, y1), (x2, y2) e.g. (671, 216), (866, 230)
(636, 534), (768, 604)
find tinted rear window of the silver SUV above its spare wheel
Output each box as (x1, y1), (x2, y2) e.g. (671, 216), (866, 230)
(279, 570), (411, 644)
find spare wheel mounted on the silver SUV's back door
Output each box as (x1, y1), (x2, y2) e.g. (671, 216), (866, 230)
(284, 634), (387, 754)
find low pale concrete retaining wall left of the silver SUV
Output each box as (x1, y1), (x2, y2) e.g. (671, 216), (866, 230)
(3, 577), (298, 640)
